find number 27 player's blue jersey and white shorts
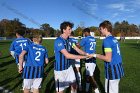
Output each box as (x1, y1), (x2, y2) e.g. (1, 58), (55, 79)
(80, 36), (96, 76)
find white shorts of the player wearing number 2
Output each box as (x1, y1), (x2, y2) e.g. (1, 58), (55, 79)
(23, 78), (42, 89)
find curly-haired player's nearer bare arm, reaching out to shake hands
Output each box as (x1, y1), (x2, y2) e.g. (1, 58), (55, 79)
(61, 49), (88, 59)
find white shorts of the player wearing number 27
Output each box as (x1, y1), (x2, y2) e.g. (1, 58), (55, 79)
(85, 63), (96, 76)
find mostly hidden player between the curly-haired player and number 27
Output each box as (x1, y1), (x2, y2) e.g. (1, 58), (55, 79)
(69, 31), (82, 91)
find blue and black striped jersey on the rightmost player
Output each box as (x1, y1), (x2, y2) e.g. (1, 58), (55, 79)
(102, 35), (124, 80)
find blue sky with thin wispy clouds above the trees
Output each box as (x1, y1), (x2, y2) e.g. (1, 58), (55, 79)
(0, 0), (140, 29)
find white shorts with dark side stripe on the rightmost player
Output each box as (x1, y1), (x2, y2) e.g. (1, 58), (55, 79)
(105, 79), (120, 93)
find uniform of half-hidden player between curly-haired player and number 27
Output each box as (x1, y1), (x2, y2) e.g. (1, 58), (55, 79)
(69, 37), (80, 67)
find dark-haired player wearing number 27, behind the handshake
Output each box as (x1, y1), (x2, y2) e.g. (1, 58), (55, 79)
(80, 28), (99, 93)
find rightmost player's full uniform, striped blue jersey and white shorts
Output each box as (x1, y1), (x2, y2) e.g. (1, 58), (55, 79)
(102, 35), (124, 93)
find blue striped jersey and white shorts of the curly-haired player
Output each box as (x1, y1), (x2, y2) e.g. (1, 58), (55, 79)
(54, 36), (76, 92)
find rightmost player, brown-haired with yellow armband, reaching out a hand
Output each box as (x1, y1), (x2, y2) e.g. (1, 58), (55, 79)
(93, 20), (124, 93)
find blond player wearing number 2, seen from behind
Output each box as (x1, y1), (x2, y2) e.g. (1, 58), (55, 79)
(19, 35), (48, 93)
